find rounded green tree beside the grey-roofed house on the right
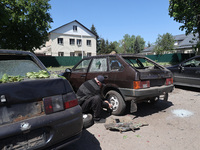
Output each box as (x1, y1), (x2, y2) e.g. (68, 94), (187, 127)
(154, 33), (175, 54)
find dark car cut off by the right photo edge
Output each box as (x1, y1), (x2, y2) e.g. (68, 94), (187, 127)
(167, 55), (200, 88)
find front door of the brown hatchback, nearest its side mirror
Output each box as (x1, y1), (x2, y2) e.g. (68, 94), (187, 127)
(70, 58), (92, 91)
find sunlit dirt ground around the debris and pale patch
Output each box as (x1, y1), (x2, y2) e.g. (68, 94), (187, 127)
(63, 87), (200, 150)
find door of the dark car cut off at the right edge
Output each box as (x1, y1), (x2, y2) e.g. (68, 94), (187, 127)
(175, 57), (200, 86)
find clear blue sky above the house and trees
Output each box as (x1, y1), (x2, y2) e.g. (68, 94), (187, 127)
(49, 0), (185, 45)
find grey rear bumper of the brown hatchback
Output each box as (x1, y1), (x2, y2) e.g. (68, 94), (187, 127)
(119, 85), (174, 101)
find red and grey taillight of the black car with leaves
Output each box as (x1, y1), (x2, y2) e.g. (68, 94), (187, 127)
(43, 93), (78, 114)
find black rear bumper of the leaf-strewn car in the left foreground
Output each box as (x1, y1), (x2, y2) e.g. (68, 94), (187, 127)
(0, 105), (83, 149)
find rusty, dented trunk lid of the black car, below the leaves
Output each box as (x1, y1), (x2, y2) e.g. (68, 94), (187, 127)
(0, 78), (72, 126)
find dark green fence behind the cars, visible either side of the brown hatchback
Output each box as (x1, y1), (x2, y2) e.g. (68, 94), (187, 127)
(38, 53), (195, 67)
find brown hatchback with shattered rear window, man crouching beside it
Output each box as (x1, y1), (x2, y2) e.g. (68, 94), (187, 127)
(63, 54), (174, 115)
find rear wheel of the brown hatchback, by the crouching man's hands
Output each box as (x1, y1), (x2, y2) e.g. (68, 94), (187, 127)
(106, 90), (126, 115)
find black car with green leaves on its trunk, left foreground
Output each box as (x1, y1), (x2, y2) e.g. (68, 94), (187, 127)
(0, 50), (83, 150)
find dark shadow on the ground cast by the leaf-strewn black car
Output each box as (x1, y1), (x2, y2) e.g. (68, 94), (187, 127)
(61, 130), (101, 150)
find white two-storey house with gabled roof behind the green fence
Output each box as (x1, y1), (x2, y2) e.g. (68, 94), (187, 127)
(35, 20), (96, 56)
